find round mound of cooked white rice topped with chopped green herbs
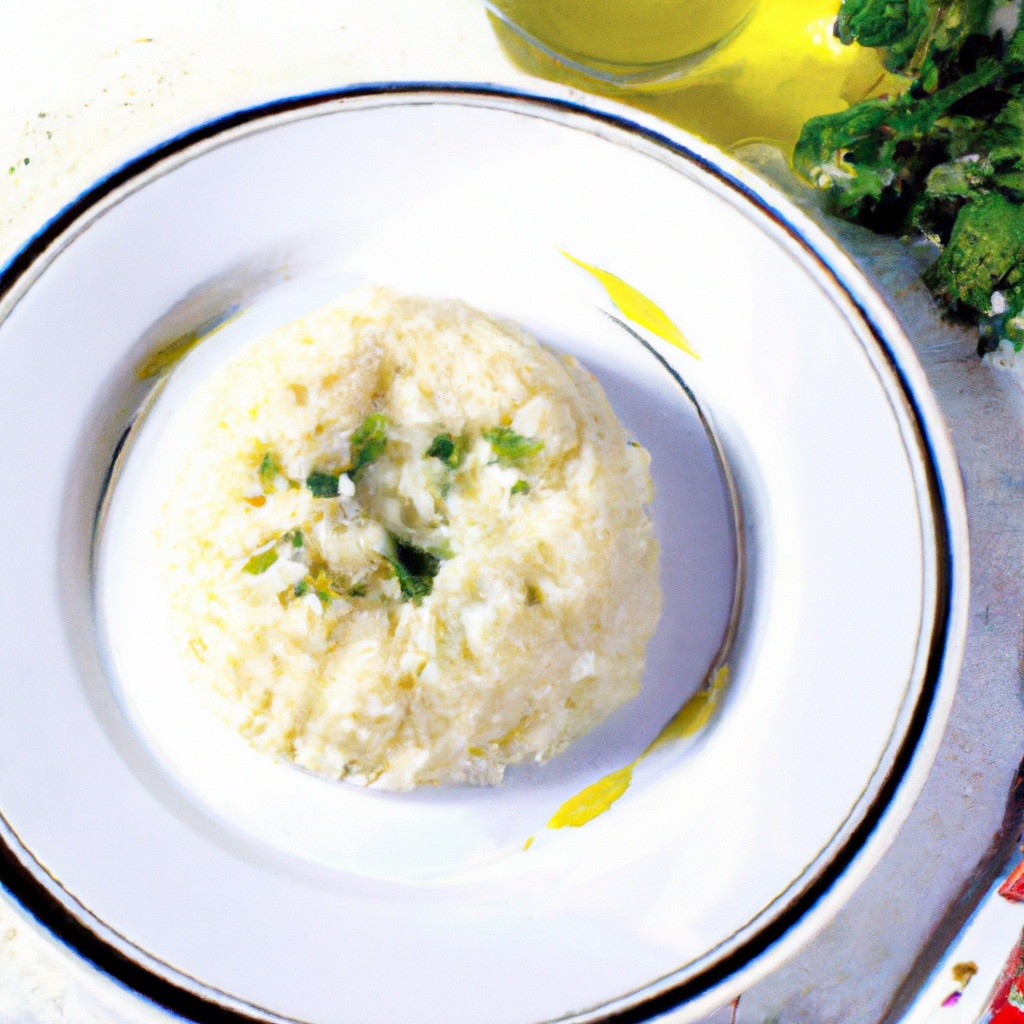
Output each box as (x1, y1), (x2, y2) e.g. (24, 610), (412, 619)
(159, 289), (662, 790)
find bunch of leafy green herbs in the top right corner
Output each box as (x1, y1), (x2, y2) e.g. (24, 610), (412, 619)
(794, 0), (1024, 351)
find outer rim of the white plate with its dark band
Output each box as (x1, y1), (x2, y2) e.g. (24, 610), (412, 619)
(0, 81), (970, 1024)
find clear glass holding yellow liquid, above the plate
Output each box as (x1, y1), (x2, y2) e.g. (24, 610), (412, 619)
(484, 0), (757, 89)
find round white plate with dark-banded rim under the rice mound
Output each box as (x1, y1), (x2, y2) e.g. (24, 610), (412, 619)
(0, 87), (967, 1024)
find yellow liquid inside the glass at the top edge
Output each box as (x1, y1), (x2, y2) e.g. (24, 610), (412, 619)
(493, 0), (756, 67)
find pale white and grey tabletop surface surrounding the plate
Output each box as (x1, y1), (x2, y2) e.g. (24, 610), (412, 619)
(0, 0), (1024, 1024)
